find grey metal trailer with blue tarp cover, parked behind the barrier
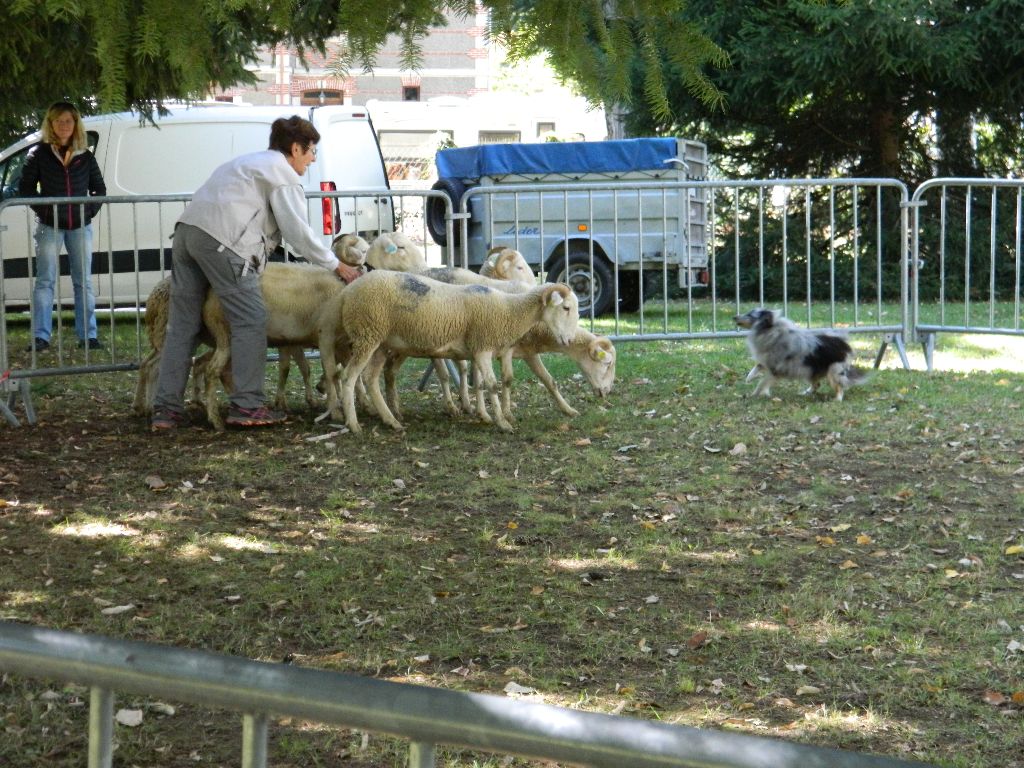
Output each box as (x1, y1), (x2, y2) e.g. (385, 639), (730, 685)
(427, 138), (708, 314)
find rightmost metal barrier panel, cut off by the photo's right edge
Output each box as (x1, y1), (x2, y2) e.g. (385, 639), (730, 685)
(910, 178), (1024, 371)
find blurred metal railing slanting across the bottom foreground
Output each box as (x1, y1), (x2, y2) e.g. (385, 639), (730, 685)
(0, 622), (925, 768)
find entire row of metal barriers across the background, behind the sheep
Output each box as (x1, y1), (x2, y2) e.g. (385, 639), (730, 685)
(0, 179), (1024, 425)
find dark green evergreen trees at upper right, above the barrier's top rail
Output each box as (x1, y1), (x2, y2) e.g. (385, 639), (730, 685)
(629, 0), (1024, 185)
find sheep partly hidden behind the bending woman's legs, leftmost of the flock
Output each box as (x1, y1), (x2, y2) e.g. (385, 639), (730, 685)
(133, 234), (370, 430)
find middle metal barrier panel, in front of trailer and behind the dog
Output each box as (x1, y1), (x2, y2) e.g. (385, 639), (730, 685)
(456, 178), (911, 368)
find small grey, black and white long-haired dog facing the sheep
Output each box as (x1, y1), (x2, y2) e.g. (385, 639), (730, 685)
(733, 308), (866, 400)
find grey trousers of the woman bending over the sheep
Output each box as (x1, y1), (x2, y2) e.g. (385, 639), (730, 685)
(154, 224), (266, 413)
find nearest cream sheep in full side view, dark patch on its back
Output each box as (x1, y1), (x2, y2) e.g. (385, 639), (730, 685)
(321, 270), (580, 432)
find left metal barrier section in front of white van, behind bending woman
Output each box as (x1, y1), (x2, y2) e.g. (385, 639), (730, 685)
(0, 188), (449, 426)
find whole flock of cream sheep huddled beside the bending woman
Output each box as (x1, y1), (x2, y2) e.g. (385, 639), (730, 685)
(134, 232), (615, 432)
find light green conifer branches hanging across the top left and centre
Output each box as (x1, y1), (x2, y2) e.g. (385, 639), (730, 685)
(0, 0), (724, 144)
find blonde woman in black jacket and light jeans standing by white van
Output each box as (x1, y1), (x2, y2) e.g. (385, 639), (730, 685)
(18, 101), (106, 352)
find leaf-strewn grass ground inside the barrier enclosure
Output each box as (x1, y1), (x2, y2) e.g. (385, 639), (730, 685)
(0, 317), (1024, 768)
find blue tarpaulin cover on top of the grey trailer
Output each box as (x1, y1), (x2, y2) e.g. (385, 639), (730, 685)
(436, 138), (677, 179)
